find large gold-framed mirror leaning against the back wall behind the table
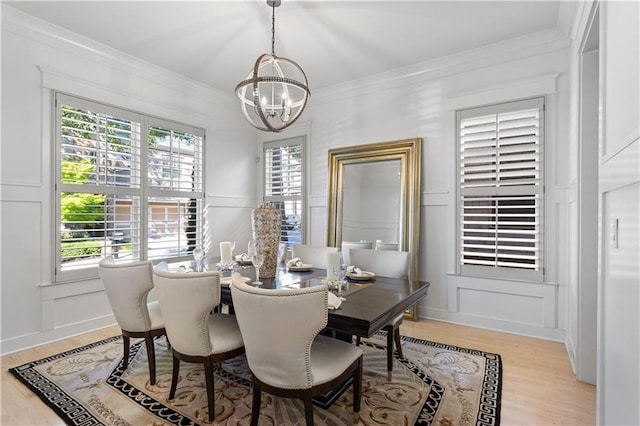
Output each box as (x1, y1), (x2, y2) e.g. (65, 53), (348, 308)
(327, 138), (422, 320)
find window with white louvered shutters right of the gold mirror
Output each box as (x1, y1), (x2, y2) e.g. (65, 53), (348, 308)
(457, 98), (544, 281)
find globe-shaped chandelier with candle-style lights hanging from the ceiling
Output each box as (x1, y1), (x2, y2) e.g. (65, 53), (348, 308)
(236, 0), (311, 132)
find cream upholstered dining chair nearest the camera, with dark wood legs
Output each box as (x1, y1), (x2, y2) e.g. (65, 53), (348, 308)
(231, 272), (362, 426)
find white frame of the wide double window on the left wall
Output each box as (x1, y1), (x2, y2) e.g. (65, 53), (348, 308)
(52, 91), (206, 283)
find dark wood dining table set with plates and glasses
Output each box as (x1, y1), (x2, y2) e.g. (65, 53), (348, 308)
(205, 263), (429, 337)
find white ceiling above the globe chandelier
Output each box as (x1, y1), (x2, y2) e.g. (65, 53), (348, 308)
(4, 0), (567, 93)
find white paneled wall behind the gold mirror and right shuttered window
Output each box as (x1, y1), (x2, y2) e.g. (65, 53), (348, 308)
(305, 32), (569, 340)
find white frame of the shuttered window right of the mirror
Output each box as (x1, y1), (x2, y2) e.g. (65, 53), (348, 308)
(455, 96), (549, 282)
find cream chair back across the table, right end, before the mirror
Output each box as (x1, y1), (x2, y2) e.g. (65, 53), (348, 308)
(349, 249), (411, 279)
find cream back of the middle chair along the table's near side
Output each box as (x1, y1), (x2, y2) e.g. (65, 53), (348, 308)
(153, 267), (220, 356)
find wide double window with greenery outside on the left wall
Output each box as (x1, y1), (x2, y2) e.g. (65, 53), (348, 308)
(55, 93), (204, 281)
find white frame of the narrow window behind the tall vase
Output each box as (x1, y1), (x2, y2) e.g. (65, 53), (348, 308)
(262, 136), (307, 250)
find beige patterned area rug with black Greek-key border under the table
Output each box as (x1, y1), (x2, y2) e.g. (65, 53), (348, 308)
(10, 333), (502, 426)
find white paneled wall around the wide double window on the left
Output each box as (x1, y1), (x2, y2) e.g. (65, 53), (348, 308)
(0, 4), (256, 353)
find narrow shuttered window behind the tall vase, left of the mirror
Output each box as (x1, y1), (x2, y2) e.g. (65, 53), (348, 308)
(264, 138), (304, 249)
